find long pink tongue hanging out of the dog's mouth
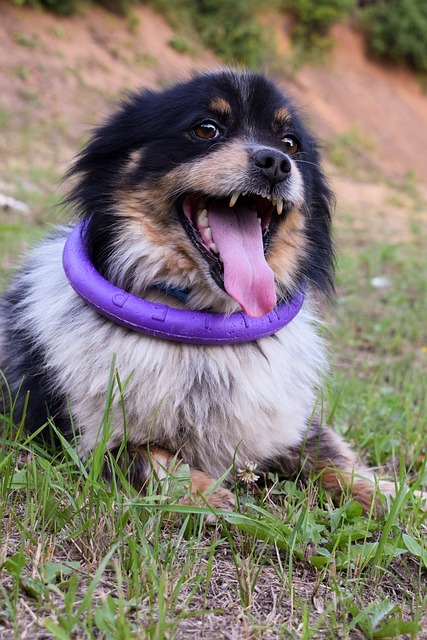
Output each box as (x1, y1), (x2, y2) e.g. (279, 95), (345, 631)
(209, 203), (277, 318)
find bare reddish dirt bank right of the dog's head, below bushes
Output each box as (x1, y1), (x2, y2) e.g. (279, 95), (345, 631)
(288, 25), (427, 180)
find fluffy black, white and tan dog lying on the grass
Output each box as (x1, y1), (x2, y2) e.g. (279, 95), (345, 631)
(0, 69), (402, 509)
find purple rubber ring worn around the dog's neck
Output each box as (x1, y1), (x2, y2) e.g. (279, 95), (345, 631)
(62, 221), (304, 345)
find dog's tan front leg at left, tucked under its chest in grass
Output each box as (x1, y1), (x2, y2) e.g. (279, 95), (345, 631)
(104, 445), (235, 511)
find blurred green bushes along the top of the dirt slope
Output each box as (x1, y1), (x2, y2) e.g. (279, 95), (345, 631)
(8, 0), (427, 73)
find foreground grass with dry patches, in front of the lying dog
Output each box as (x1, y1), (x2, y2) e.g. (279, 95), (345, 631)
(0, 388), (427, 639)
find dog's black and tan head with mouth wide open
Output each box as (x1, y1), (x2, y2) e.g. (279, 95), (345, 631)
(70, 71), (333, 317)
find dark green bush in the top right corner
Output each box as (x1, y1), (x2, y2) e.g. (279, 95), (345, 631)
(360, 0), (427, 73)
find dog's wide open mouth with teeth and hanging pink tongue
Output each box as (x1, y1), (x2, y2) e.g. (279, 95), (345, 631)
(182, 193), (283, 318)
